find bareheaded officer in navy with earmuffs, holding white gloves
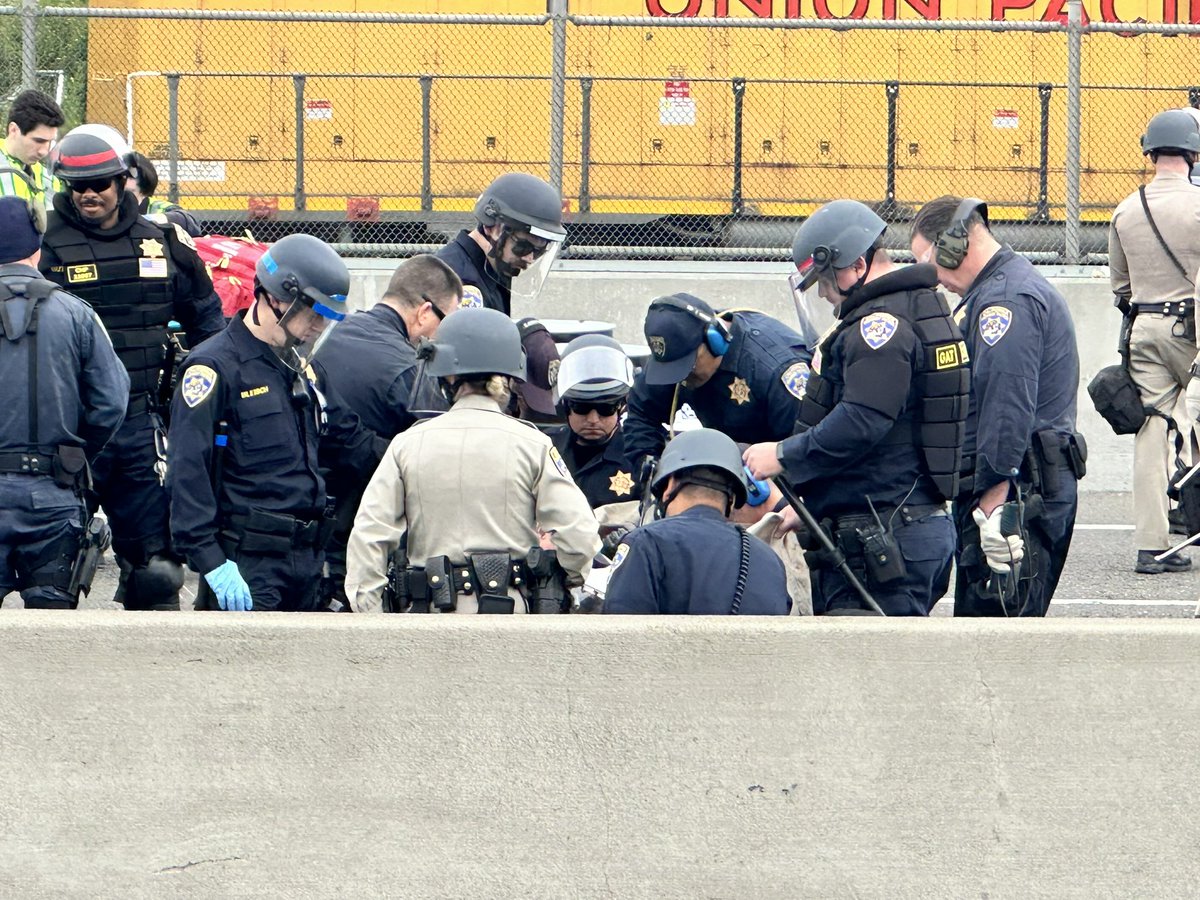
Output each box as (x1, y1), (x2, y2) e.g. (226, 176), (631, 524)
(912, 197), (1087, 616)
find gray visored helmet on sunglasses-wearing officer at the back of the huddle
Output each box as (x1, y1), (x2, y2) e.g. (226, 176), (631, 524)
(475, 172), (566, 300)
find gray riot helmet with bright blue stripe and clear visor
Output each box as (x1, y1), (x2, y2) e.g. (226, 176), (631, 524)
(253, 234), (350, 372)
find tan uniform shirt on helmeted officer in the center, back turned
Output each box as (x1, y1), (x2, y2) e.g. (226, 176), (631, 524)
(346, 395), (600, 612)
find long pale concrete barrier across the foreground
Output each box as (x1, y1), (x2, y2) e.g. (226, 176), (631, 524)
(0, 611), (1200, 898)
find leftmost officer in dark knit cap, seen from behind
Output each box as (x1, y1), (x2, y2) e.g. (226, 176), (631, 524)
(0, 197), (130, 610)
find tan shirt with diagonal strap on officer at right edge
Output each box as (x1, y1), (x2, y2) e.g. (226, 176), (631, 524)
(1109, 173), (1200, 304)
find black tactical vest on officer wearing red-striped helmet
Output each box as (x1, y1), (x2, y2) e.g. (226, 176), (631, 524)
(43, 215), (175, 397)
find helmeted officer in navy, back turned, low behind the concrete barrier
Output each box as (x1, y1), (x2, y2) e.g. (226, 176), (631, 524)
(604, 428), (791, 616)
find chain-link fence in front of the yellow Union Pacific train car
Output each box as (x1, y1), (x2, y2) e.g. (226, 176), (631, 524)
(0, 0), (1200, 262)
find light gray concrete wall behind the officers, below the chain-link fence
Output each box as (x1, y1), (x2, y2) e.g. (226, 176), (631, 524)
(352, 259), (1133, 491)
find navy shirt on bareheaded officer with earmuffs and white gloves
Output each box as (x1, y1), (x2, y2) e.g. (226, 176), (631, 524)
(960, 247), (1079, 494)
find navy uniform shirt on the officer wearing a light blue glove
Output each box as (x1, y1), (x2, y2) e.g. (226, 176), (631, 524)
(167, 313), (386, 572)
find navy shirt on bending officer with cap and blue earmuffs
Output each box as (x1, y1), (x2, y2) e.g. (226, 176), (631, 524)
(624, 312), (811, 476)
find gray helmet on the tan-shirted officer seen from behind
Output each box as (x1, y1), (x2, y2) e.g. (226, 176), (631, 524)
(418, 307), (526, 382)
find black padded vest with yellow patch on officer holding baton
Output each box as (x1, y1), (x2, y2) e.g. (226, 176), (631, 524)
(797, 280), (971, 500)
